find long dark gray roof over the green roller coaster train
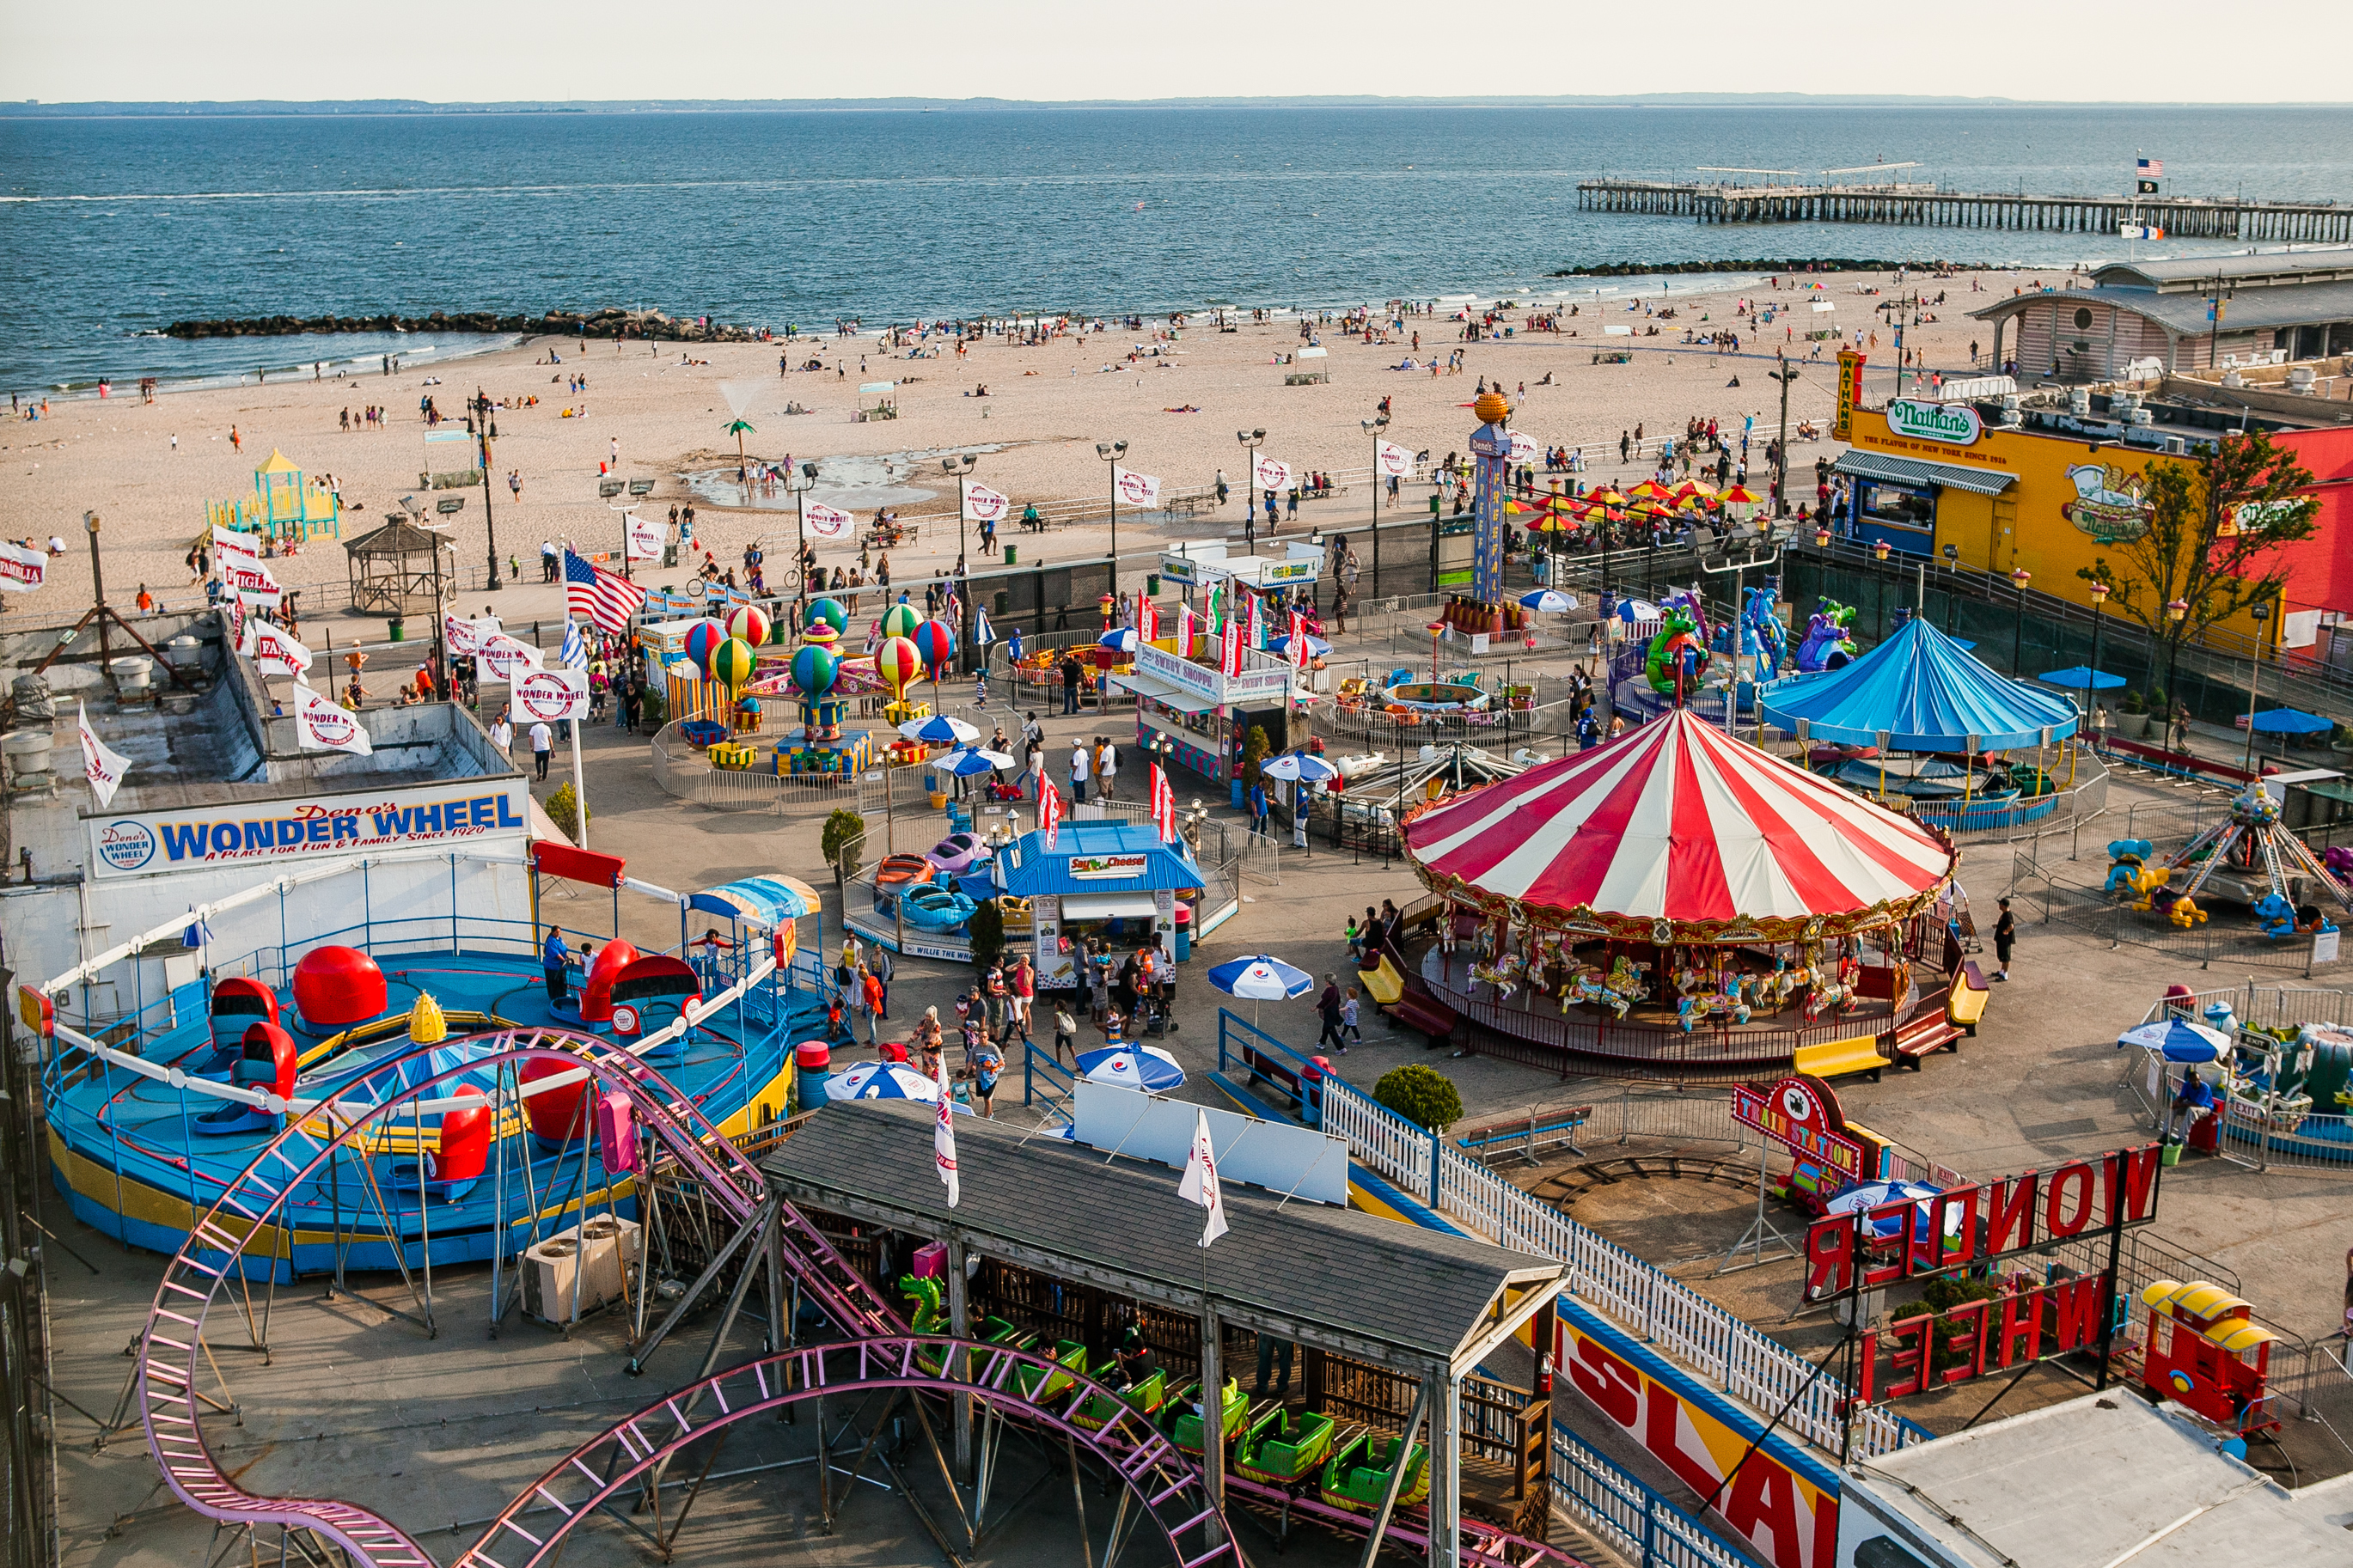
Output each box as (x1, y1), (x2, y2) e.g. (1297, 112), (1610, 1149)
(760, 1101), (1565, 1361)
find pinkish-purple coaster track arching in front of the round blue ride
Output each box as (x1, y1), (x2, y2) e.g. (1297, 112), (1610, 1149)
(137, 1029), (903, 1568)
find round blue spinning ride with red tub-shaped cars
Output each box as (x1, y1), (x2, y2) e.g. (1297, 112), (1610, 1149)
(21, 844), (823, 1281)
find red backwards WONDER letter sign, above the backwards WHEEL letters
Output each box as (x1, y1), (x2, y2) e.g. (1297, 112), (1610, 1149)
(1805, 1143), (2158, 1303)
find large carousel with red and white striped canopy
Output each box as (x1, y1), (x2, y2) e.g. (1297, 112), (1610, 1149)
(1405, 708), (1958, 1070)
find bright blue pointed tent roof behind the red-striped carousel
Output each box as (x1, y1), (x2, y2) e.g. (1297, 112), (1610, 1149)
(1763, 616), (2082, 753)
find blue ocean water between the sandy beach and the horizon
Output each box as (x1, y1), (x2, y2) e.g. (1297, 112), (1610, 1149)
(0, 106), (2353, 390)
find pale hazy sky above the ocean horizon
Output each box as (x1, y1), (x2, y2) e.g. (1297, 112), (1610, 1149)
(0, 0), (2353, 103)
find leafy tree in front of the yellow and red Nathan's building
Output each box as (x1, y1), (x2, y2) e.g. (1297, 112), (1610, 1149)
(2075, 430), (2320, 696)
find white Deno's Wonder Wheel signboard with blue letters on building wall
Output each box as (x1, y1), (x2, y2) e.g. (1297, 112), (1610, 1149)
(89, 778), (529, 879)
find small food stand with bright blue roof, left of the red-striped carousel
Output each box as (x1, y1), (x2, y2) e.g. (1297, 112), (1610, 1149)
(995, 823), (1202, 990)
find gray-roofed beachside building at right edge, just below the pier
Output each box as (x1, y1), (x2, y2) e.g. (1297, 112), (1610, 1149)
(1971, 249), (2353, 381)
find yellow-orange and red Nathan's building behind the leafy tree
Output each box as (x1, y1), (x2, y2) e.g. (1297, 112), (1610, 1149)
(1836, 390), (2353, 646)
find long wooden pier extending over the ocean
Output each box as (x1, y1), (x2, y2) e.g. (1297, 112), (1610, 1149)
(1576, 179), (2353, 242)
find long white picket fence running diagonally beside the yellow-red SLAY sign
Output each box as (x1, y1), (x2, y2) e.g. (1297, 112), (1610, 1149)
(1323, 1079), (1917, 1460)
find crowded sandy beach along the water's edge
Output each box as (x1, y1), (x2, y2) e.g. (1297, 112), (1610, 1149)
(0, 268), (2063, 637)
